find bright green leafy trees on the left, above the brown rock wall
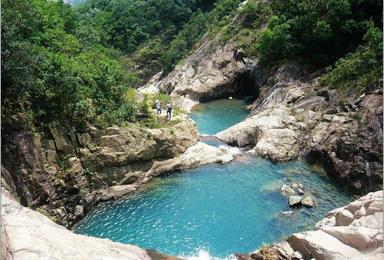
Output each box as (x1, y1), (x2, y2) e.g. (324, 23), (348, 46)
(1, 0), (142, 129)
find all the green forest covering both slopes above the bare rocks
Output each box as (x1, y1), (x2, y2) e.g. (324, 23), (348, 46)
(1, 0), (382, 127)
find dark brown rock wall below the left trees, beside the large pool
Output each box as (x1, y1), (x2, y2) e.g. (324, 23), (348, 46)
(1, 121), (198, 226)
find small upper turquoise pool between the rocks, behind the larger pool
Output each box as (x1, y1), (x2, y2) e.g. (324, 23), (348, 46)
(190, 99), (249, 135)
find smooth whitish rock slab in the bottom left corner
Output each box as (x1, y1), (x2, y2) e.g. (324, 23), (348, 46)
(1, 192), (151, 260)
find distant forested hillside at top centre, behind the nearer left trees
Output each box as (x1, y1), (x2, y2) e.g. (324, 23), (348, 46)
(78, 0), (241, 83)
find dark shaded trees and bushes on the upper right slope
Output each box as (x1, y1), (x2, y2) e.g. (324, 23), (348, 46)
(231, 0), (383, 91)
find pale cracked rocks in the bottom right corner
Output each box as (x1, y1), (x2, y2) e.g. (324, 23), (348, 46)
(251, 191), (384, 260)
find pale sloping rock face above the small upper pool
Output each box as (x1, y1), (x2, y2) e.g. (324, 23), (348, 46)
(159, 41), (246, 101)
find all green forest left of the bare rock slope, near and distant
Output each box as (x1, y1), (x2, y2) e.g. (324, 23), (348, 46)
(2, 0), (244, 127)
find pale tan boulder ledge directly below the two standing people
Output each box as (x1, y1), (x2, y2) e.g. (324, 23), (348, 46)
(80, 121), (197, 169)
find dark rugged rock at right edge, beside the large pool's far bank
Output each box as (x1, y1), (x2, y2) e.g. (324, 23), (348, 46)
(306, 94), (383, 193)
